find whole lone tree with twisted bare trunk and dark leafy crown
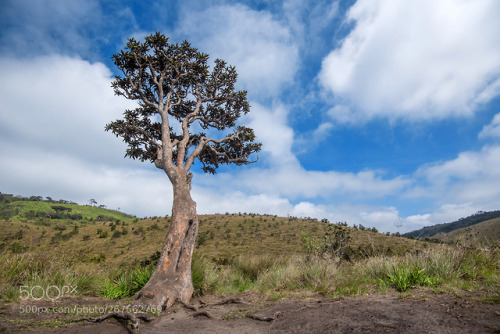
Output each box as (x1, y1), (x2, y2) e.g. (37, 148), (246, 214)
(106, 33), (261, 310)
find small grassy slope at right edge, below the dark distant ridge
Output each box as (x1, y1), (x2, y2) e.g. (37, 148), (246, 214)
(433, 218), (500, 246)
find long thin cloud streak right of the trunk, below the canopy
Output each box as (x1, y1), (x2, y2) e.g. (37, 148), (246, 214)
(193, 165), (411, 204)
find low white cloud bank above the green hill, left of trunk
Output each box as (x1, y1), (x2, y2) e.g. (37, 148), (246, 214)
(0, 142), (172, 217)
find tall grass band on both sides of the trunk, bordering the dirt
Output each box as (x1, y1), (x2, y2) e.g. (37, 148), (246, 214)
(0, 247), (500, 302)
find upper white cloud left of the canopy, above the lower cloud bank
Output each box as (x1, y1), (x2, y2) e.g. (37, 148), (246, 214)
(0, 56), (135, 167)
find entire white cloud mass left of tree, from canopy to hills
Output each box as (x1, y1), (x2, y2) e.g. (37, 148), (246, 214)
(0, 56), (171, 214)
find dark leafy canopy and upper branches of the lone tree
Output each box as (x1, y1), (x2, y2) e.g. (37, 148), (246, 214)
(106, 33), (261, 177)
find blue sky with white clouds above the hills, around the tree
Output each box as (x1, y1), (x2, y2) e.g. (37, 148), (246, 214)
(0, 0), (500, 232)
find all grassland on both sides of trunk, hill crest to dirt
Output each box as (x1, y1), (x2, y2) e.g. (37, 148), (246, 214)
(0, 214), (500, 301)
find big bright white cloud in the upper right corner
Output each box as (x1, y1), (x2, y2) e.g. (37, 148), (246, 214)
(319, 0), (500, 122)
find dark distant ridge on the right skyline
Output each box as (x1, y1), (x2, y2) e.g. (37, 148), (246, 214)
(403, 210), (500, 239)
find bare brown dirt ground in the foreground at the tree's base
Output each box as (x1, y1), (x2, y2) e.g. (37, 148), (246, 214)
(0, 290), (500, 334)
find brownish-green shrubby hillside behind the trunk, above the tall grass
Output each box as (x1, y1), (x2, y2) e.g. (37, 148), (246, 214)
(0, 214), (432, 266)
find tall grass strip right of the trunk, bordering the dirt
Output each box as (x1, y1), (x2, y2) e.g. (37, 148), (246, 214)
(187, 247), (500, 296)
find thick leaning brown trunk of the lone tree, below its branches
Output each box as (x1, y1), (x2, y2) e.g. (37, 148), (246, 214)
(134, 177), (198, 311)
